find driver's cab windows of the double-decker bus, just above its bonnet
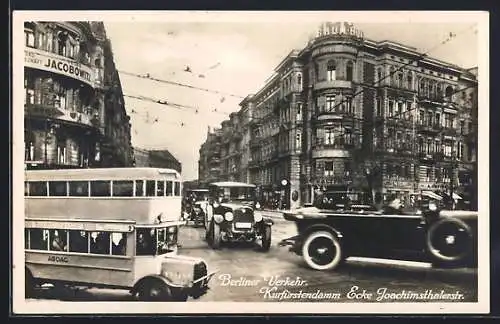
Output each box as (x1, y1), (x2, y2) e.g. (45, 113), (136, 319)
(136, 226), (177, 255)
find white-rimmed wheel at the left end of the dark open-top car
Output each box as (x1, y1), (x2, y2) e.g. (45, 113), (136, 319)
(302, 231), (342, 271)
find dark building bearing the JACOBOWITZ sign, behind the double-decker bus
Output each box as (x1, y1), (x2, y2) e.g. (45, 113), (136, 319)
(24, 22), (134, 169)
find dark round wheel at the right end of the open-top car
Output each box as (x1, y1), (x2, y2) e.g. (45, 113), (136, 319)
(426, 218), (473, 266)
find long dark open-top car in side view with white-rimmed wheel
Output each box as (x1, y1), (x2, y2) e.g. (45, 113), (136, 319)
(280, 202), (478, 270)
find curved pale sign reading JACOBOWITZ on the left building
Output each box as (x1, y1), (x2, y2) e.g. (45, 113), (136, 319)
(24, 48), (94, 86)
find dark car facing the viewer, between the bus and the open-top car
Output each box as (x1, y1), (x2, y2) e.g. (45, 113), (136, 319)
(205, 182), (273, 251)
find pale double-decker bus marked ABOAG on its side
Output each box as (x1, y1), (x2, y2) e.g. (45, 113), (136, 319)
(24, 168), (213, 301)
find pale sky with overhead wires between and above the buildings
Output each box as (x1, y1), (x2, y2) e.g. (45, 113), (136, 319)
(104, 12), (478, 180)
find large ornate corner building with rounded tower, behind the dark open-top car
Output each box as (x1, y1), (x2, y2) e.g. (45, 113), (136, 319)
(198, 23), (477, 208)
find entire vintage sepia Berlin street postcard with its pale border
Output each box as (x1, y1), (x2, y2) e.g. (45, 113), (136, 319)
(12, 11), (490, 314)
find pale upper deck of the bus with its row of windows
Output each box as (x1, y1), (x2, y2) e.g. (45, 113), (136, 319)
(25, 168), (182, 224)
